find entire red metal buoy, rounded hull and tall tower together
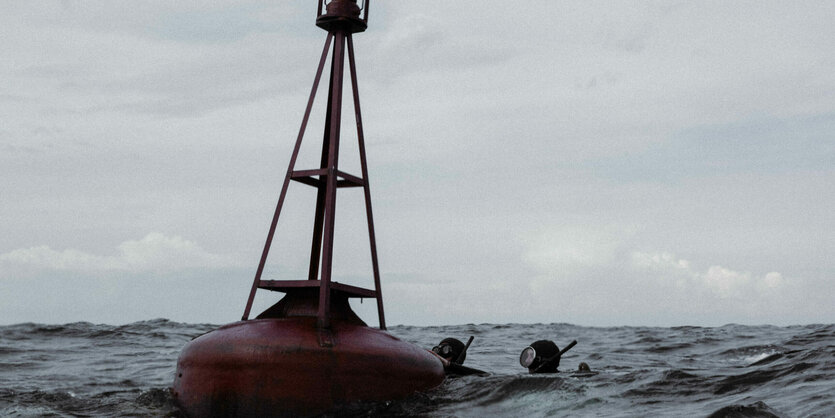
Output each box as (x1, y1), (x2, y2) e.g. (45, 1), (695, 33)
(172, 0), (444, 416)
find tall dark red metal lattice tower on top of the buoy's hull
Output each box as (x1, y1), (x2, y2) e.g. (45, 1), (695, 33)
(242, 0), (386, 334)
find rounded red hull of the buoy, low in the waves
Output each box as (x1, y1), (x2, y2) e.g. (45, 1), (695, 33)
(172, 317), (444, 417)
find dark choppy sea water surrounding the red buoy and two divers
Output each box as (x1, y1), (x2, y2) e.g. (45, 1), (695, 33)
(0, 319), (835, 417)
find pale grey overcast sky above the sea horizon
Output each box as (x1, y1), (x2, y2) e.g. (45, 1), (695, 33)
(0, 0), (835, 326)
